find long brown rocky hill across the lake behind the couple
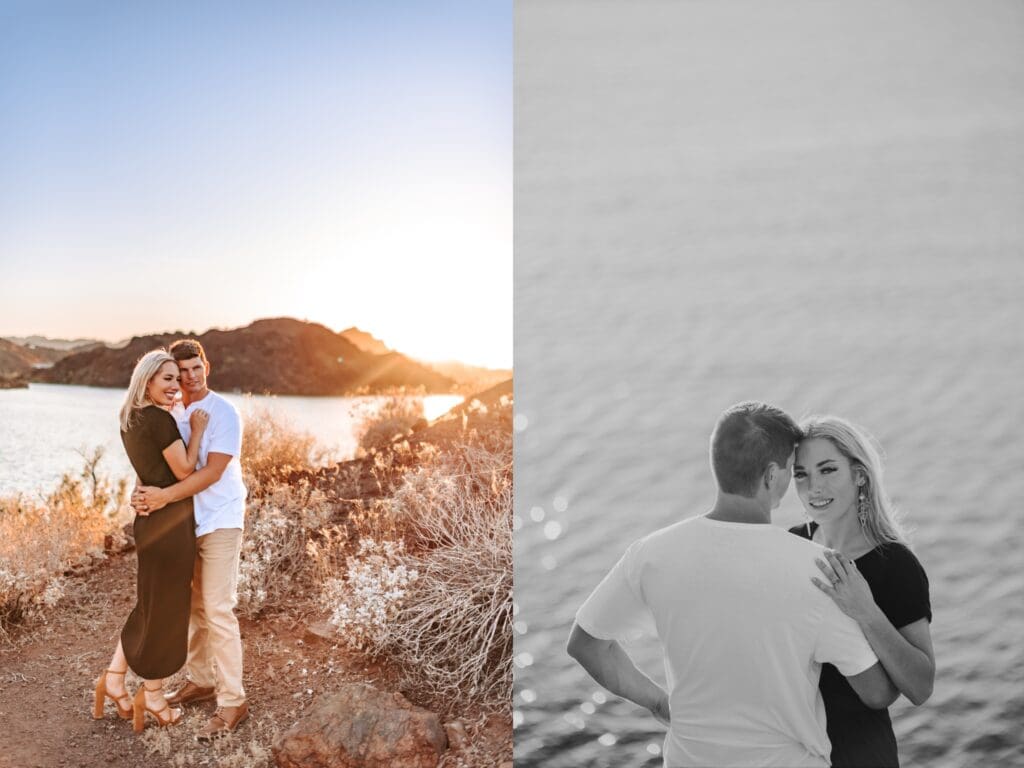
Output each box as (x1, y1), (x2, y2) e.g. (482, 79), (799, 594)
(33, 317), (455, 395)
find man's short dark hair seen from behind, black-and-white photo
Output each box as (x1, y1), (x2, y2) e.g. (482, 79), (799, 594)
(711, 400), (803, 497)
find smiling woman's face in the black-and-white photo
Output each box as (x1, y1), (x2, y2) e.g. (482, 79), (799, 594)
(793, 437), (858, 522)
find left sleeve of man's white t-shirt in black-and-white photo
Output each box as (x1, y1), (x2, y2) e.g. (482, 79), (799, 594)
(575, 542), (654, 642)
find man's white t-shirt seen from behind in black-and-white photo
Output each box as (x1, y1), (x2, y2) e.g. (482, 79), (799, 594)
(577, 517), (878, 768)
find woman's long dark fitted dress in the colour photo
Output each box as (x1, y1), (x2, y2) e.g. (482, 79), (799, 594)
(121, 406), (196, 680)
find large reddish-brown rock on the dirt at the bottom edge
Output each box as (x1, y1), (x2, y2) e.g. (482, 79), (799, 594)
(273, 684), (447, 768)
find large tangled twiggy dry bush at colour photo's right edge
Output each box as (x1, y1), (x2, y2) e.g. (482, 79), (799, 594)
(325, 435), (512, 709)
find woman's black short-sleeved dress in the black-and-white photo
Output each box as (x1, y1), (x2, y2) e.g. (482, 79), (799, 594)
(790, 522), (932, 768)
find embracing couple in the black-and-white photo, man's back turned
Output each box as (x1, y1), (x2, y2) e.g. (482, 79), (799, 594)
(568, 402), (935, 768)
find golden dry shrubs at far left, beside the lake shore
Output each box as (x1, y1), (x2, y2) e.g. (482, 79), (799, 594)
(0, 447), (129, 637)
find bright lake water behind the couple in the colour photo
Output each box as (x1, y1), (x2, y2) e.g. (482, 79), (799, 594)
(0, 384), (463, 495)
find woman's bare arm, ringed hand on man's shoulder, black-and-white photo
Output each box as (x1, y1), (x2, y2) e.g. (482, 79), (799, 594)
(813, 550), (935, 706)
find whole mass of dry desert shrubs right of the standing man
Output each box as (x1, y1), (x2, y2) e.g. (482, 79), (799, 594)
(239, 396), (512, 714)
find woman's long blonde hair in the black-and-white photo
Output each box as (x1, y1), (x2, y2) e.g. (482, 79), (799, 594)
(801, 416), (909, 547)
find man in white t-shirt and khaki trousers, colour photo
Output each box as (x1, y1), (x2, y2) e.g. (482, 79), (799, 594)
(132, 339), (249, 740)
